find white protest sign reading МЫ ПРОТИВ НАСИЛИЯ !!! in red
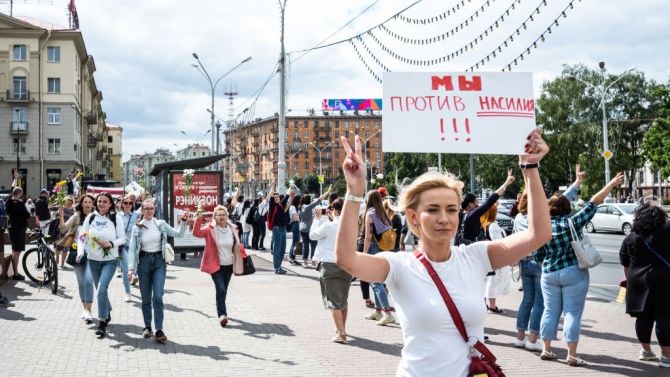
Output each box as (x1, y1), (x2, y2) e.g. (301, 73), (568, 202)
(382, 72), (535, 154)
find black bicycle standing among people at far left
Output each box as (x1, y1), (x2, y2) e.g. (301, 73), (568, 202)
(23, 223), (58, 294)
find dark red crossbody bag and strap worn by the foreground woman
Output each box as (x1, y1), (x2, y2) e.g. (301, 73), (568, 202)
(414, 250), (505, 377)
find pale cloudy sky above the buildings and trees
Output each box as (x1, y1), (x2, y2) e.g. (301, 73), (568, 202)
(6, 0), (670, 161)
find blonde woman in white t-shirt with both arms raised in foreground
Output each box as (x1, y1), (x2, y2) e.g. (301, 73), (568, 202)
(335, 129), (551, 376)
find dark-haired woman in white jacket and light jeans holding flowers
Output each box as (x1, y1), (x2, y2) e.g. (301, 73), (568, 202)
(77, 192), (126, 337)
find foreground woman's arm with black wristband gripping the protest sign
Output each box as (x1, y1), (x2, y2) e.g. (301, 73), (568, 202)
(488, 128), (551, 269)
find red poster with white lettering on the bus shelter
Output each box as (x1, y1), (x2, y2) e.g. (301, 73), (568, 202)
(170, 170), (223, 246)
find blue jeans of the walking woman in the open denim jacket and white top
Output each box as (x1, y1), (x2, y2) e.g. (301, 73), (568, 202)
(137, 253), (167, 331)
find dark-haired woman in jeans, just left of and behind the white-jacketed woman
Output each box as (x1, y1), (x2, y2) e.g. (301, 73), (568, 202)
(58, 194), (95, 323)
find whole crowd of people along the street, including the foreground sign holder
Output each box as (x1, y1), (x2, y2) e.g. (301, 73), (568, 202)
(0, 130), (670, 376)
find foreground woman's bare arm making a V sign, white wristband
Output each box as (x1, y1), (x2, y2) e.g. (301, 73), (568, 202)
(335, 136), (390, 281)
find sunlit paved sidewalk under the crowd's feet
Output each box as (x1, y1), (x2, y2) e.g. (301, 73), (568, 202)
(0, 238), (670, 377)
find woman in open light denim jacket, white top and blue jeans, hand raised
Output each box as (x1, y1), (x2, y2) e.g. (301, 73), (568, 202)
(128, 200), (189, 342)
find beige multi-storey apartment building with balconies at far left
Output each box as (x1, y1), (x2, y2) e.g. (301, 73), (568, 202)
(0, 14), (107, 196)
